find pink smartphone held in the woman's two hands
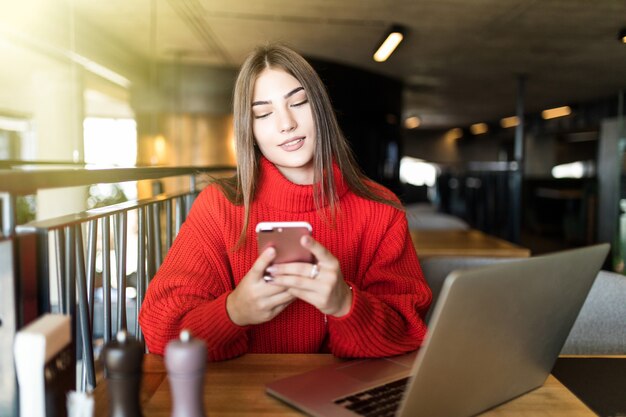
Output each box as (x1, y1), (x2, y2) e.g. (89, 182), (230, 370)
(256, 222), (313, 264)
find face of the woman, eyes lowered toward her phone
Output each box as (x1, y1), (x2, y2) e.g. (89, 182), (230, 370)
(252, 68), (316, 184)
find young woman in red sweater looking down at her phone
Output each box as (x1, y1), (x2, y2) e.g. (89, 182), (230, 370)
(139, 45), (431, 360)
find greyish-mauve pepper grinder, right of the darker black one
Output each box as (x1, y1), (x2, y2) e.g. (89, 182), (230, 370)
(165, 330), (207, 417)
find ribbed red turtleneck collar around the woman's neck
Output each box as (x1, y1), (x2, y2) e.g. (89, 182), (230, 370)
(254, 156), (348, 213)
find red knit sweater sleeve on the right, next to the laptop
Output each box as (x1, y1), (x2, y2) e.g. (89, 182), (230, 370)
(328, 212), (432, 358)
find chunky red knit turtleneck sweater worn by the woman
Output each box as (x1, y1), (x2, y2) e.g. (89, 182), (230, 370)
(139, 158), (431, 360)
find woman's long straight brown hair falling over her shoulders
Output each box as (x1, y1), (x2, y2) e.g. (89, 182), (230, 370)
(217, 44), (402, 245)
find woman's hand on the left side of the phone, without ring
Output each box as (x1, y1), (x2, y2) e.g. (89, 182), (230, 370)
(226, 248), (295, 326)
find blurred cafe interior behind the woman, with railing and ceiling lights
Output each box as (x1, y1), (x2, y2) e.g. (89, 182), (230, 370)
(0, 0), (626, 415)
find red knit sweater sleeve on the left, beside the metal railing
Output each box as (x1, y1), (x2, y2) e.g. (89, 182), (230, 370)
(139, 193), (248, 361)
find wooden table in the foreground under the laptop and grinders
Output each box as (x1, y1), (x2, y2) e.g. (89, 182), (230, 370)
(94, 354), (595, 417)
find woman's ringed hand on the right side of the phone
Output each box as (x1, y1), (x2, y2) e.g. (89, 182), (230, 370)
(268, 236), (352, 317)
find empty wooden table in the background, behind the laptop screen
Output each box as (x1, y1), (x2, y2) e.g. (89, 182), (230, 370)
(410, 229), (530, 259)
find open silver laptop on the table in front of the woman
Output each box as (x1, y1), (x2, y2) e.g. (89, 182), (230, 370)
(266, 244), (609, 417)
